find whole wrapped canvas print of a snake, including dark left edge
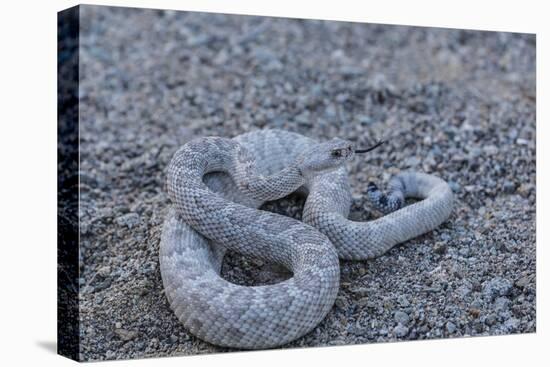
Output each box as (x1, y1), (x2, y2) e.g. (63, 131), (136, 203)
(58, 5), (536, 361)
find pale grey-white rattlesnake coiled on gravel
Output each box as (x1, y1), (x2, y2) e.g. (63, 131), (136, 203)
(159, 129), (453, 349)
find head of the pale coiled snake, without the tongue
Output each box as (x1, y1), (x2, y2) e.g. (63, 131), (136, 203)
(298, 138), (354, 177)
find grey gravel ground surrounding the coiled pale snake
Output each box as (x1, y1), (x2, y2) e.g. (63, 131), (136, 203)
(78, 6), (536, 360)
